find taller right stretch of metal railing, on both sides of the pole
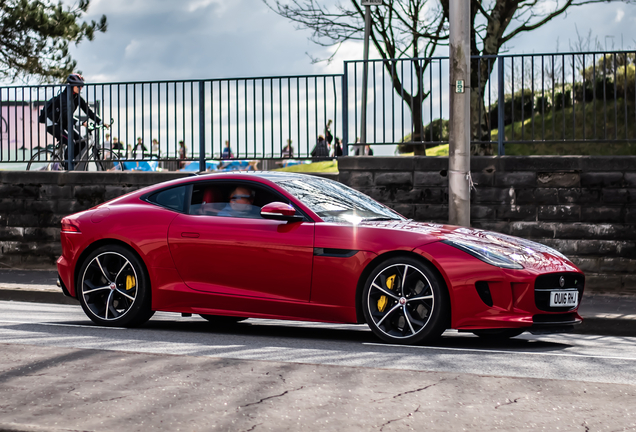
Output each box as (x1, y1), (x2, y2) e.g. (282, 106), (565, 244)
(343, 51), (636, 155)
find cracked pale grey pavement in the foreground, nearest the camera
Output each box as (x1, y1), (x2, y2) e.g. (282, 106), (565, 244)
(0, 344), (636, 432)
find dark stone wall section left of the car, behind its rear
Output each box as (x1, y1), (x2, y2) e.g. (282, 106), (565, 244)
(0, 171), (187, 269)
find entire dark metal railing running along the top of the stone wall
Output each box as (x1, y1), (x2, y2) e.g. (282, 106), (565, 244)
(0, 51), (636, 169)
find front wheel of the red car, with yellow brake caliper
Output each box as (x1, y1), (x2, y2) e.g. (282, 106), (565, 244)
(362, 257), (450, 344)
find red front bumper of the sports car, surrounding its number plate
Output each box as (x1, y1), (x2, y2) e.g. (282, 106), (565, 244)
(414, 243), (585, 333)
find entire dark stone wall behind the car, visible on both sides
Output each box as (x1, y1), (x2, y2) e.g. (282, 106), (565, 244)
(0, 156), (636, 294)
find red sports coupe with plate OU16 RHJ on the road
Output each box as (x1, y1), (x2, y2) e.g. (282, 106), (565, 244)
(57, 172), (585, 344)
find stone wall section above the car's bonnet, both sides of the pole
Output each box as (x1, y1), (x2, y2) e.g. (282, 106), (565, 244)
(339, 156), (636, 294)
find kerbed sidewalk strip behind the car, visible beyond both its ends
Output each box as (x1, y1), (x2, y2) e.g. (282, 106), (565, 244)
(0, 269), (636, 337)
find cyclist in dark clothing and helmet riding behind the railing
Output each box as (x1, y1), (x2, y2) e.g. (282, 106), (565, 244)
(39, 73), (109, 164)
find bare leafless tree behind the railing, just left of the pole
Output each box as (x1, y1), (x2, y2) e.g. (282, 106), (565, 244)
(263, 0), (448, 154)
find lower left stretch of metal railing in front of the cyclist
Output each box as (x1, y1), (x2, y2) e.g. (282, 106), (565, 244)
(0, 75), (342, 168)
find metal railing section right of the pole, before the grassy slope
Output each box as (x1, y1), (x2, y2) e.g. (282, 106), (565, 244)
(486, 51), (636, 153)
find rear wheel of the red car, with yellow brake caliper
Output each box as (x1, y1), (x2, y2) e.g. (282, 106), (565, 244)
(76, 244), (154, 327)
